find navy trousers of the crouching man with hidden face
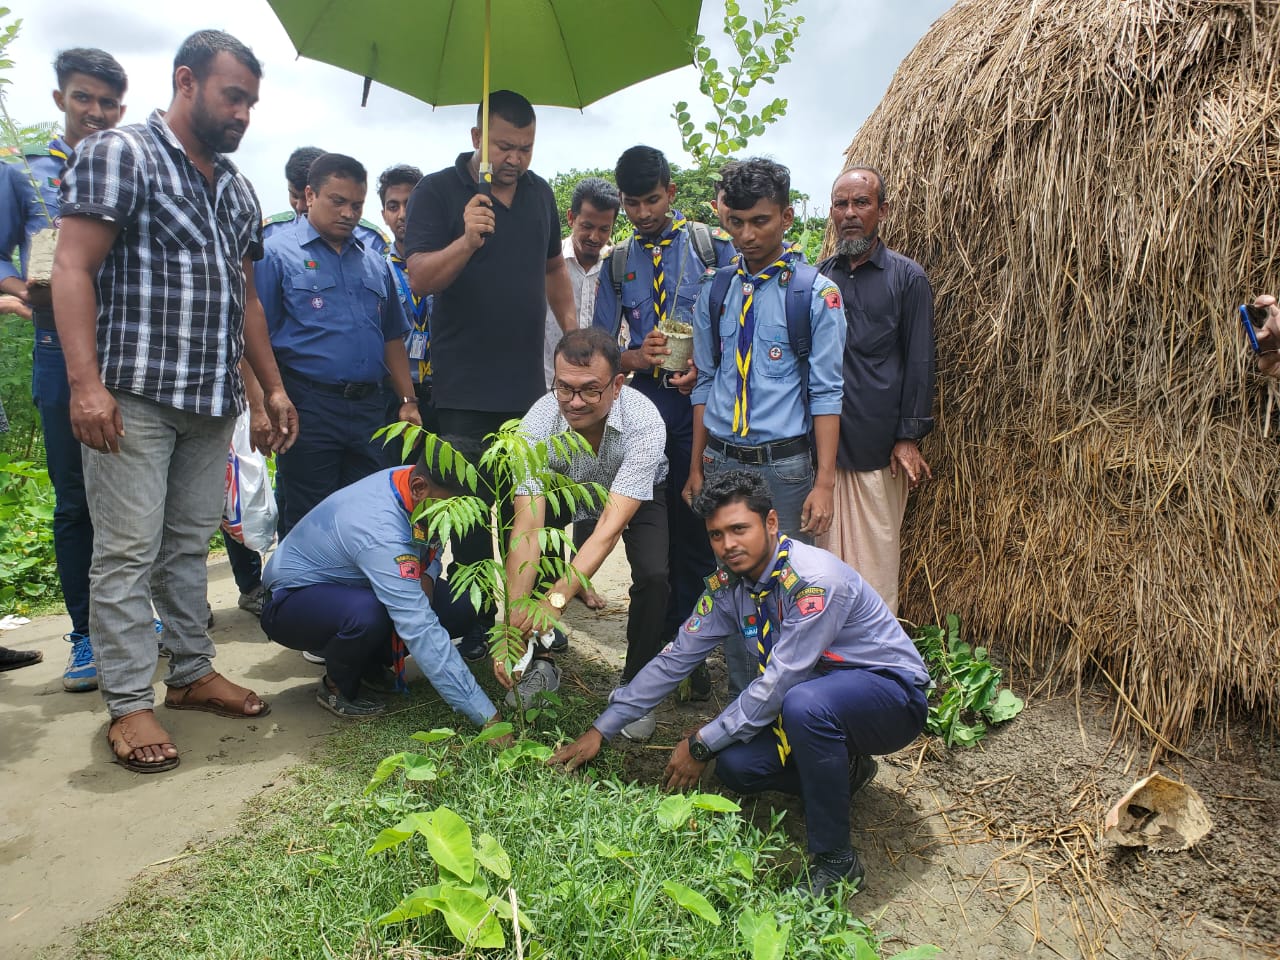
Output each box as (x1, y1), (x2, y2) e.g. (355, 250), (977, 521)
(261, 577), (476, 699)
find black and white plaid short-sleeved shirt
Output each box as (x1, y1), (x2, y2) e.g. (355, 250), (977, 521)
(61, 110), (262, 416)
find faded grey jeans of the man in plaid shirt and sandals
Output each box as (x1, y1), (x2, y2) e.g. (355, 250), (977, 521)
(83, 390), (236, 718)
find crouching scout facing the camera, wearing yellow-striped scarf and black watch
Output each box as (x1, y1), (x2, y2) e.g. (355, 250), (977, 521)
(550, 470), (929, 897)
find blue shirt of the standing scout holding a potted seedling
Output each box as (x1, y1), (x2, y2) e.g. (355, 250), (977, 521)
(591, 210), (736, 350)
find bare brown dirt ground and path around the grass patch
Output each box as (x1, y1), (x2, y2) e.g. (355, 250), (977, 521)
(0, 550), (1280, 960)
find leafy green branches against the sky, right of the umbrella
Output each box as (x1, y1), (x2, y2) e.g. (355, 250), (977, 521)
(672, 0), (804, 169)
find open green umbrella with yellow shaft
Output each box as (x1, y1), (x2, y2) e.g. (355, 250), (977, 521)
(269, 0), (701, 185)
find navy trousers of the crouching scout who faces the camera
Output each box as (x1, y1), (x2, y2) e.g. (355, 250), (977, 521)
(716, 669), (929, 854)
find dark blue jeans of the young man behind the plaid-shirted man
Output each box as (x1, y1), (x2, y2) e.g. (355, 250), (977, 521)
(31, 329), (93, 634)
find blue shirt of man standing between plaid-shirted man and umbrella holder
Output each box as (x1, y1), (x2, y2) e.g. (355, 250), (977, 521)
(253, 218), (408, 384)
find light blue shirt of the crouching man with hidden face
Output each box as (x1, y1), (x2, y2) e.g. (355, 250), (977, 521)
(262, 467), (497, 726)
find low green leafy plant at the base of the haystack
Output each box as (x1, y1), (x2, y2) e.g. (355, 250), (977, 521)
(911, 613), (1023, 746)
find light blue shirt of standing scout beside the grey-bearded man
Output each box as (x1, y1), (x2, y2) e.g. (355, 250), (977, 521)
(690, 263), (846, 447)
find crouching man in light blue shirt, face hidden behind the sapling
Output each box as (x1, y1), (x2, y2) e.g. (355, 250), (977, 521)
(261, 450), (497, 726)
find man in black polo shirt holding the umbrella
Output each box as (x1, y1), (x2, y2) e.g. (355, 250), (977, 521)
(404, 90), (577, 660)
